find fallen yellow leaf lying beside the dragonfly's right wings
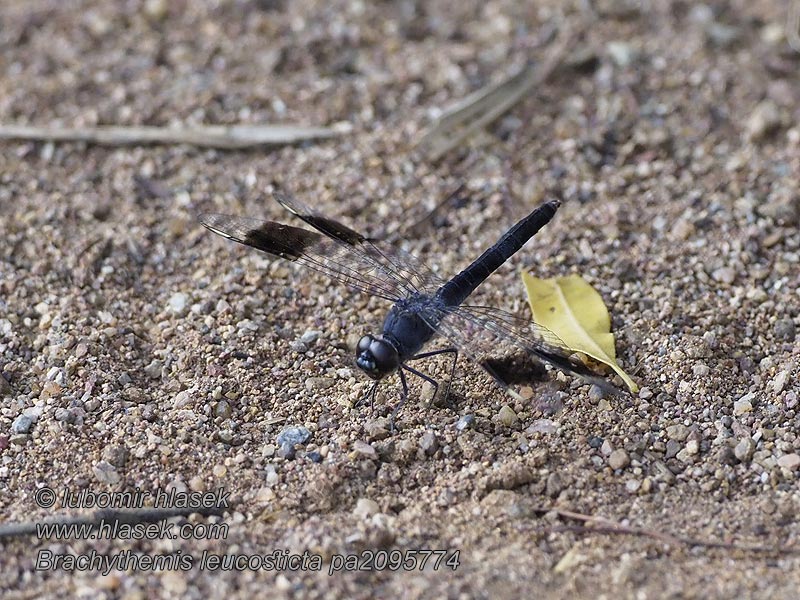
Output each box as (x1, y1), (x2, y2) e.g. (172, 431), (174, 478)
(522, 272), (639, 393)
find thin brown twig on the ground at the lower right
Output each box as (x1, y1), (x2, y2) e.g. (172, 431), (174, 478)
(535, 508), (800, 554)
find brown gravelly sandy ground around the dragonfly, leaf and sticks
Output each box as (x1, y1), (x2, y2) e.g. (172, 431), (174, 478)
(0, 0), (800, 599)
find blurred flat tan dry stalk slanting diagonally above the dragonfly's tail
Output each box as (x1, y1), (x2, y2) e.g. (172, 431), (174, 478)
(418, 32), (575, 161)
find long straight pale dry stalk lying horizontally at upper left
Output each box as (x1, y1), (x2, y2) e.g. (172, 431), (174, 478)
(0, 124), (350, 150)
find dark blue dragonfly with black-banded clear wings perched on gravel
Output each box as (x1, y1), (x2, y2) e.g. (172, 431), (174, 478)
(199, 189), (617, 429)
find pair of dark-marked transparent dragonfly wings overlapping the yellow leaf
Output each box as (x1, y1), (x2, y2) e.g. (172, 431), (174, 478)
(438, 305), (619, 394)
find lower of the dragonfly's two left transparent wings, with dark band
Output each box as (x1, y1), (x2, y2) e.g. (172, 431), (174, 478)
(200, 214), (416, 302)
